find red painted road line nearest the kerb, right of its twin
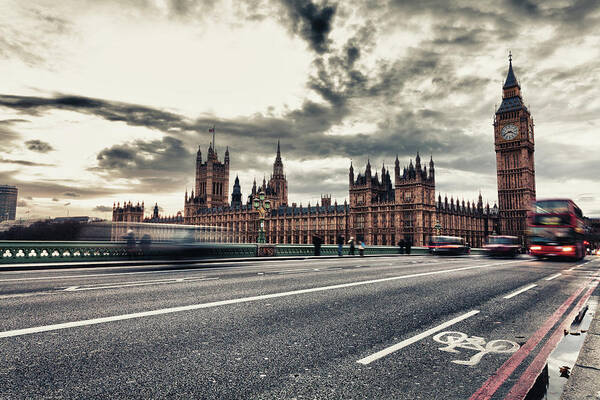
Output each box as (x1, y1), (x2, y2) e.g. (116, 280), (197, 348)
(504, 281), (598, 400)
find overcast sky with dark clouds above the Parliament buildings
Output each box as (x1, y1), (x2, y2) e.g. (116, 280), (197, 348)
(0, 0), (600, 218)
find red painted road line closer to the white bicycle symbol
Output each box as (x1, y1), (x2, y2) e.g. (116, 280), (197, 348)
(469, 280), (591, 400)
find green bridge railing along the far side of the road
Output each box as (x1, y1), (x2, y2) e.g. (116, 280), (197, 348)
(0, 241), (481, 264)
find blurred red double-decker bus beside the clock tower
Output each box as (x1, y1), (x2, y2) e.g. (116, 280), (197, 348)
(528, 199), (585, 260)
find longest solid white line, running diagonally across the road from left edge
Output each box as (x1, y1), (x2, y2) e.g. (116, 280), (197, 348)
(0, 261), (520, 338)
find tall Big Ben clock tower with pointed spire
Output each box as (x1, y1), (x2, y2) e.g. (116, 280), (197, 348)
(494, 55), (535, 238)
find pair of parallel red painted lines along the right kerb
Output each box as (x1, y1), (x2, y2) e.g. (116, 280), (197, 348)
(469, 279), (598, 400)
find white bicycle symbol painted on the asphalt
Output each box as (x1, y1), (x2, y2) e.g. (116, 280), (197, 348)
(433, 331), (520, 366)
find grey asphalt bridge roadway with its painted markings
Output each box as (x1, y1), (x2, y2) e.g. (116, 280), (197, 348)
(0, 256), (600, 399)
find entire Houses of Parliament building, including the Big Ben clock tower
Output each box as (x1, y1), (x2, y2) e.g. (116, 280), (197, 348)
(113, 57), (535, 247)
